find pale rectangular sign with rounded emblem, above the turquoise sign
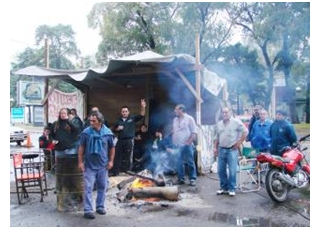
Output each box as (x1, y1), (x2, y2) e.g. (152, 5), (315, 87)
(17, 81), (45, 105)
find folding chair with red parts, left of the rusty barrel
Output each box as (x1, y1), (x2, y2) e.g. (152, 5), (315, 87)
(13, 152), (48, 204)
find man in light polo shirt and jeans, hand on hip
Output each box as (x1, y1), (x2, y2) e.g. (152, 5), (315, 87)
(214, 107), (248, 196)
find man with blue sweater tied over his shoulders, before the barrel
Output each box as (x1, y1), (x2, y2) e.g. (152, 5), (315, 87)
(78, 111), (115, 219)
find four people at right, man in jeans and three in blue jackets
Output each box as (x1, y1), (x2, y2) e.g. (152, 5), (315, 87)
(214, 105), (297, 196)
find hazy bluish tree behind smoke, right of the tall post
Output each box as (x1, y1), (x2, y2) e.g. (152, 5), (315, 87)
(209, 43), (266, 111)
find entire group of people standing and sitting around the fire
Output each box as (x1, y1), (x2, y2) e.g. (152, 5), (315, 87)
(39, 99), (297, 219)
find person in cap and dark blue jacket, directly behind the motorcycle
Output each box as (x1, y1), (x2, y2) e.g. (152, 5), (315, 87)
(270, 110), (297, 156)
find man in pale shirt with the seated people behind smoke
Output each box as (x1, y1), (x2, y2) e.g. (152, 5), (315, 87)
(132, 104), (197, 186)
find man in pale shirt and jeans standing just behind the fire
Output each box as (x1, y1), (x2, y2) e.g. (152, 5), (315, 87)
(172, 104), (197, 186)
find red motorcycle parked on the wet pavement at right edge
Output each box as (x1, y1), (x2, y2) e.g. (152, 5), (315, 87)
(257, 134), (310, 203)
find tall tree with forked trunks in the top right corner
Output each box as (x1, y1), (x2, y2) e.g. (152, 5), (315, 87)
(229, 2), (310, 121)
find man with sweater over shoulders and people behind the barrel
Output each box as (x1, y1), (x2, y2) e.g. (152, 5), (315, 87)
(39, 108), (115, 219)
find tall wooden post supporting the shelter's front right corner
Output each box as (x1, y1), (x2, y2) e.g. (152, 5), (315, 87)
(195, 34), (203, 174)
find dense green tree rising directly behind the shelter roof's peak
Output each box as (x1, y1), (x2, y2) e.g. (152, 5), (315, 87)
(88, 2), (177, 64)
